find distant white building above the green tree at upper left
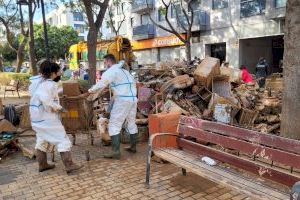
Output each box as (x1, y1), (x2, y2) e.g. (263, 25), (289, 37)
(39, 5), (88, 41)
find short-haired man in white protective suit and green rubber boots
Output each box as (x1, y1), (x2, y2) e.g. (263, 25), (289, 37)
(89, 54), (138, 159)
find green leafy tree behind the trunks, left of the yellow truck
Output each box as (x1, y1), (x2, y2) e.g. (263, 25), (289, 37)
(34, 24), (80, 60)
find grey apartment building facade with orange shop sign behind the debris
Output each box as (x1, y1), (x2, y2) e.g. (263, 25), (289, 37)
(103, 0), (286, 72)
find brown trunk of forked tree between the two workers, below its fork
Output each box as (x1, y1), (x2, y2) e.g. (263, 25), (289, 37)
(87, 26), (97, 84)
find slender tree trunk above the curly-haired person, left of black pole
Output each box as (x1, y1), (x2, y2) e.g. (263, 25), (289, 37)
(28, 1), (37, 75)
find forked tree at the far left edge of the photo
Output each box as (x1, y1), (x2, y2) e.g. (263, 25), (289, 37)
(0, 0), (28, 72)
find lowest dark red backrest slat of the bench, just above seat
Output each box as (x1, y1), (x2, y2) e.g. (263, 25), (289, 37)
(177, 138), (300, 187)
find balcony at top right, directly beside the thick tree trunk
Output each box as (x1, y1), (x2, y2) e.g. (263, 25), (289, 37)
(266, 0), (286, 20)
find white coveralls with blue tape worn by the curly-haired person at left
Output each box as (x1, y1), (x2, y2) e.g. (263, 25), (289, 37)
(29, 76), (72, 152)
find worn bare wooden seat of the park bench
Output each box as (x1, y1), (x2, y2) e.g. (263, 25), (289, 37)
(154, 149), (288, 200)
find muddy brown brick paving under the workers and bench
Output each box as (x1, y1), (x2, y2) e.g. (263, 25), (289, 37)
(0, 135), (248, 200)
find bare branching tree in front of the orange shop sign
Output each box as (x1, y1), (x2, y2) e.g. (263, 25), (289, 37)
(146, 0), (194, 63)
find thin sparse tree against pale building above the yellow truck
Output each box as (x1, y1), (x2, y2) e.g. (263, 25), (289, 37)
(107, 0), (126, 36)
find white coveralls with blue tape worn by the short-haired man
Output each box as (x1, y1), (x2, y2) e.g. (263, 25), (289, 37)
(89, 61), (138, 136)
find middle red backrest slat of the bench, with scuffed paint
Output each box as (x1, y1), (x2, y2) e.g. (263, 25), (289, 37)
(178, 125), (300, 169)
